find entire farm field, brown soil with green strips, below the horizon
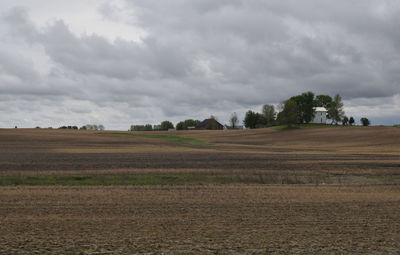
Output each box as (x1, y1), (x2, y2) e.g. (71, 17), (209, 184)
(0, 126), (400, 254)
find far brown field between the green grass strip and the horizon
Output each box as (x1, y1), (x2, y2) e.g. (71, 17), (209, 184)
(0, 127), (400, 185)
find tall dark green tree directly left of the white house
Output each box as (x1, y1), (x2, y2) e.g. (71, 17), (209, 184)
(290, 91), (315, 123)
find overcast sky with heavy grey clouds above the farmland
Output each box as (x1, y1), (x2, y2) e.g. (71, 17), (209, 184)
(0, 0), (400, 130)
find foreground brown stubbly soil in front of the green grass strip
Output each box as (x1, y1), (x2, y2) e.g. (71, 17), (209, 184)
(0, 185), (400, 254)
